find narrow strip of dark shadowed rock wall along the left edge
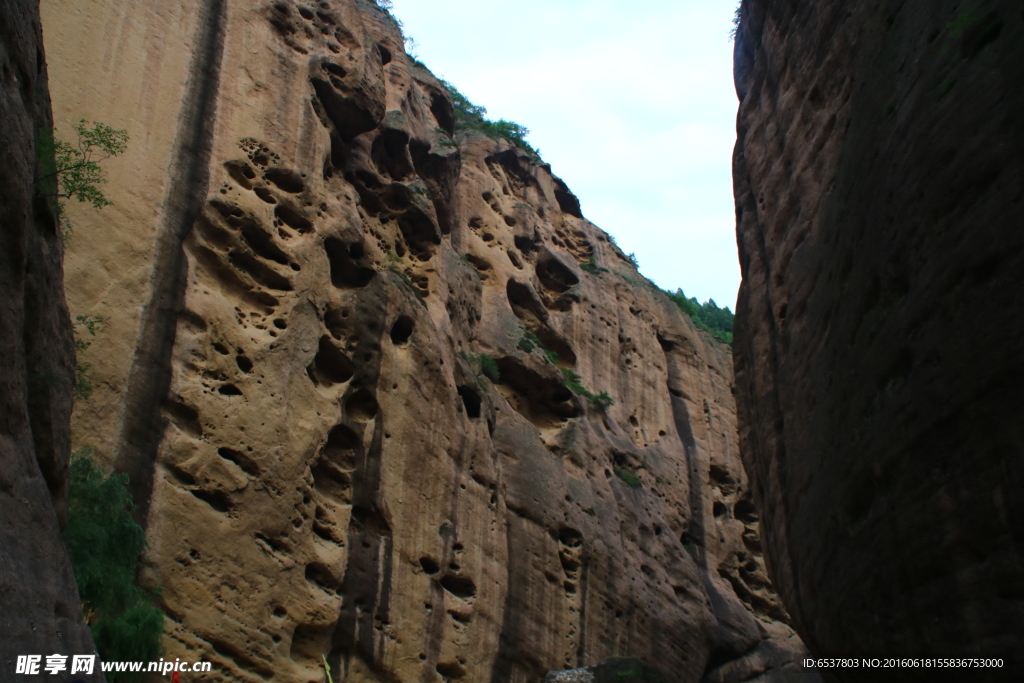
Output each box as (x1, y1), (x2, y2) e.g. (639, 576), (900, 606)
(0, 0), (94, 667)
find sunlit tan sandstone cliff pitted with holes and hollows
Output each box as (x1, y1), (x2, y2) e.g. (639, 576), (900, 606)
(47, 1), (801, 683)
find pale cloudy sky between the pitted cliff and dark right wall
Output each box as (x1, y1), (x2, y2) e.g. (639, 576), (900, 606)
(392, 0), (739, 309)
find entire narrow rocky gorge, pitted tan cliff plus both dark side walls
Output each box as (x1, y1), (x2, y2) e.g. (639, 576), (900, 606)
(0, 0), (1024, 683)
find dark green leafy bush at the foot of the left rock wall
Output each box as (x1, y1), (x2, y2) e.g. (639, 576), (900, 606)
(63, 449), (164, 683)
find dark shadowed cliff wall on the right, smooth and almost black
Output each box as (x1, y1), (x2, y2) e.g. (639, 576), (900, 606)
(734, 0), (1024, 680)
